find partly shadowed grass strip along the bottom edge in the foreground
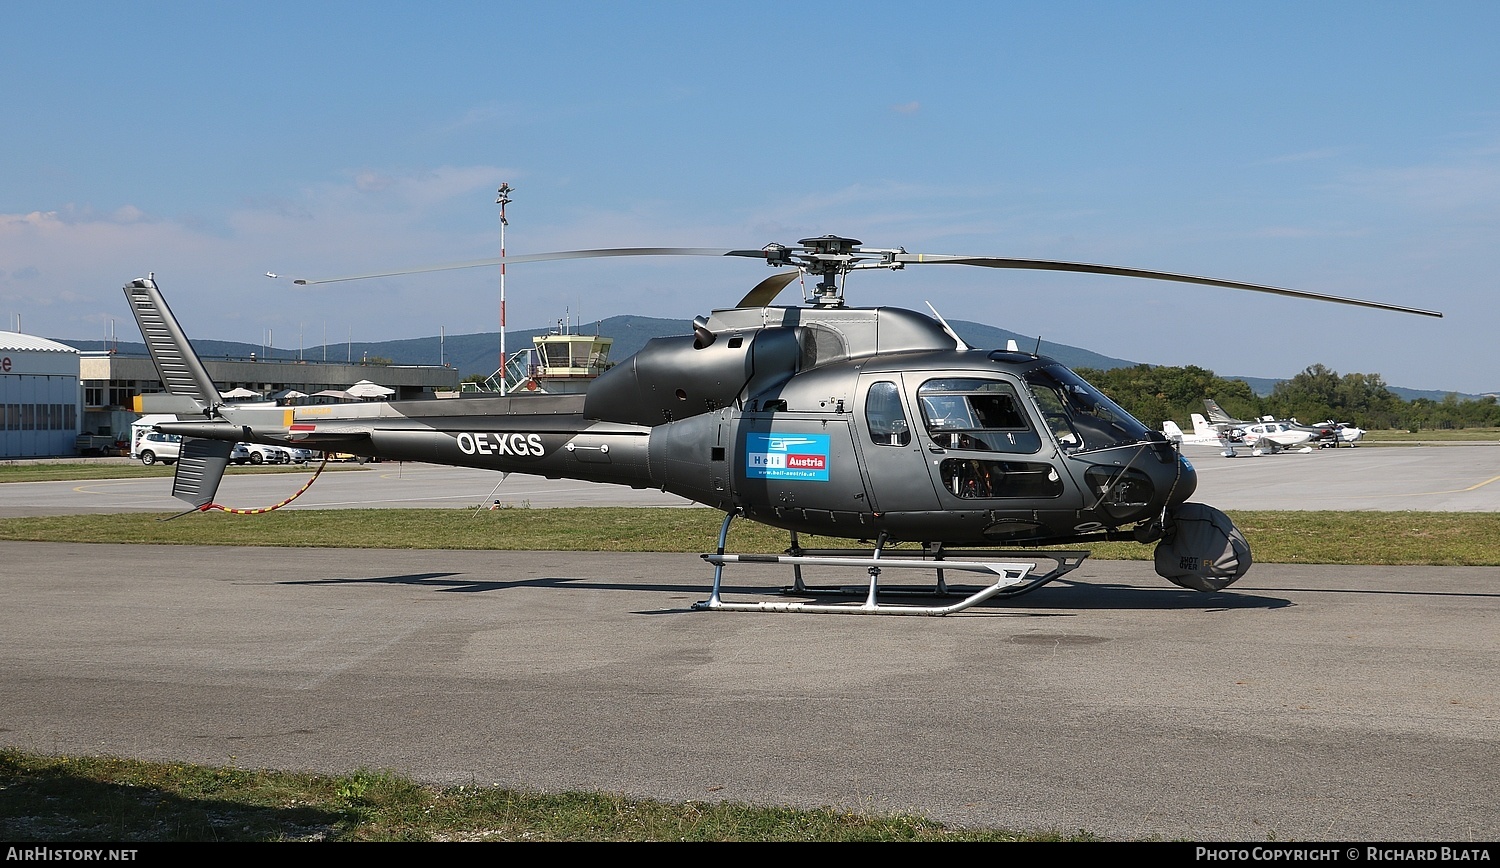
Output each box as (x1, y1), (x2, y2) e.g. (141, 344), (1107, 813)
(0, 748), (1100, 844)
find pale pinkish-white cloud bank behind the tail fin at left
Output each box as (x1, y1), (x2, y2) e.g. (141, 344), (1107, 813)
(0, 166), (503, 340)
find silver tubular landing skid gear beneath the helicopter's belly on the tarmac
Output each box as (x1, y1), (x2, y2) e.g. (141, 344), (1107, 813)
(693, 513), (1089, 616)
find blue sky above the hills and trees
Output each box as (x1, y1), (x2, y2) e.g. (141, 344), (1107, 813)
(0, 0), (1500, 393)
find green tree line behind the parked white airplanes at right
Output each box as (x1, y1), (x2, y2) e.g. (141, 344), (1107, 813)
(1077, 364), (1500, 432)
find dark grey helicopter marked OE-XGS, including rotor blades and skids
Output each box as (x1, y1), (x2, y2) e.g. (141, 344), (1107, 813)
(125, 235), (1442, 615)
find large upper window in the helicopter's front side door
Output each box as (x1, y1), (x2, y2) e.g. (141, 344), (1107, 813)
(917, 378), (1041, 453)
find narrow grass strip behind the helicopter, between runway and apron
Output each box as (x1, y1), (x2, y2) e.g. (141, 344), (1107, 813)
(0, 507), (1500, 567)
